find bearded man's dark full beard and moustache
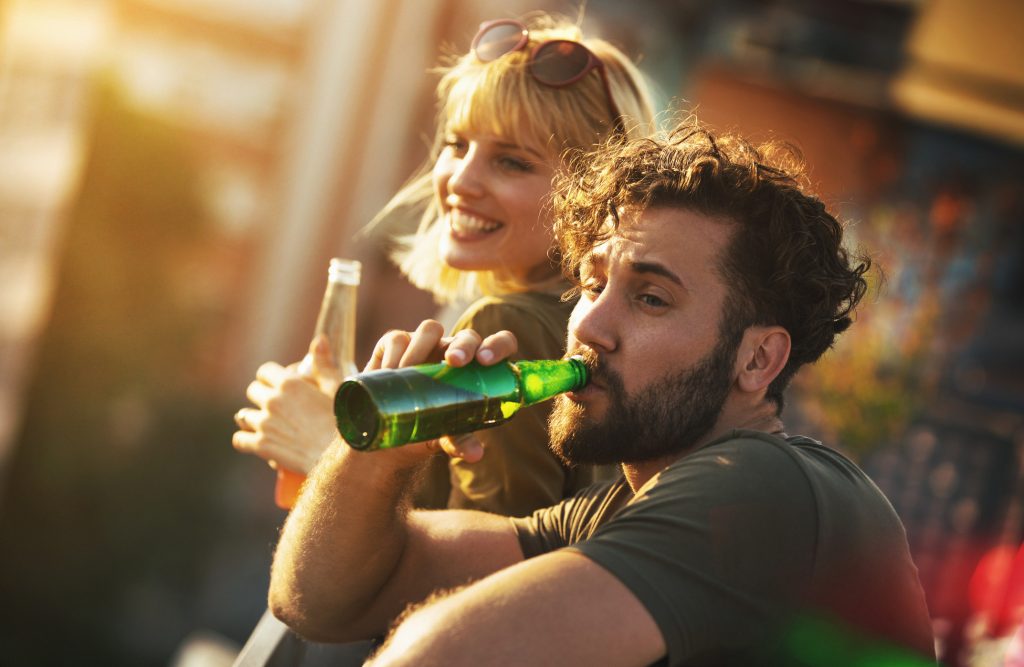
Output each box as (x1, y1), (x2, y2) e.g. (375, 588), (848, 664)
(548, 330), (742, 465)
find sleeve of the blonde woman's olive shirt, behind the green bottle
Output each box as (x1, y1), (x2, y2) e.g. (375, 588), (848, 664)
(449, 300), (566, 516)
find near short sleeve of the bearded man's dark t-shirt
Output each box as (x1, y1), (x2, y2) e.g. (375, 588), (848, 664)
(569, 441), (816, 665)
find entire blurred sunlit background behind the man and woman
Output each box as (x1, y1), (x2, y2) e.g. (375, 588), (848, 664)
(0, 0), (1024, 665)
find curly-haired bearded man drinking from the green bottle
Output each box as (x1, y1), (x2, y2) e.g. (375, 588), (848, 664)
(270, 124), (933, 666)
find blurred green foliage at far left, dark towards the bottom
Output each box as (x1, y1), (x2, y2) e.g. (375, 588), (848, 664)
(0, 76), (253, 665)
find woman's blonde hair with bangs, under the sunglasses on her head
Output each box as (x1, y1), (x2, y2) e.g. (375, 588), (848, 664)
(371, 13), (653, 303)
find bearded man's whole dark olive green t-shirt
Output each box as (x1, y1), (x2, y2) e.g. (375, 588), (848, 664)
(512, 430), (934, 666)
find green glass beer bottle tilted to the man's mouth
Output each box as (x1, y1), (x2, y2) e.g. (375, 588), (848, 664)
(334, 358), (588, 450)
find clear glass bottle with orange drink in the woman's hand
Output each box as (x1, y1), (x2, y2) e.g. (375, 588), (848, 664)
(273, 257), (362, 509)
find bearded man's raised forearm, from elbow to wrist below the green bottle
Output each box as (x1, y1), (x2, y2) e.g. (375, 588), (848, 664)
(269, 443), (420, 640)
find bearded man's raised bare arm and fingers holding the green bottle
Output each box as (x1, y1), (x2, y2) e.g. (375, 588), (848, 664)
(269, 321), (522, 641)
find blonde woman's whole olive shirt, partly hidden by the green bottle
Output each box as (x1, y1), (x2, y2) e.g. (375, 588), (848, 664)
(416, 292), (618, 516)
